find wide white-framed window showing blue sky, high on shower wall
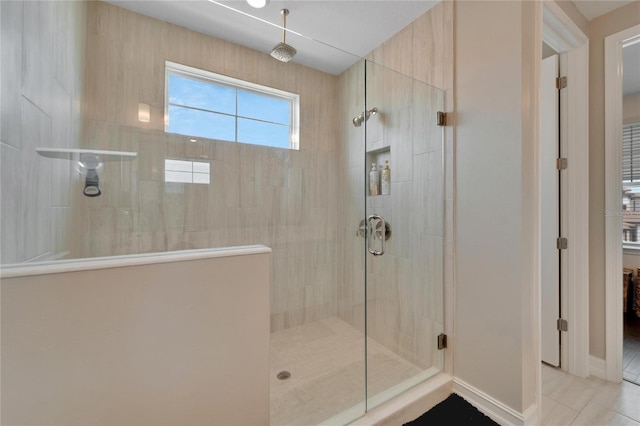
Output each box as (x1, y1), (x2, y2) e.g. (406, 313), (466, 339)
(165, 61), (299, 149)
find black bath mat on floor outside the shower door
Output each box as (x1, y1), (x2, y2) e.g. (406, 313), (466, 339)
(404, 393), (499, 426)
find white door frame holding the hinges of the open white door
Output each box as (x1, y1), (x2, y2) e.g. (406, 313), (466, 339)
(542, 1), (590, 377)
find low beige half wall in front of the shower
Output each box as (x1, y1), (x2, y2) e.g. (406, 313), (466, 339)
(2, 247), (271, 426)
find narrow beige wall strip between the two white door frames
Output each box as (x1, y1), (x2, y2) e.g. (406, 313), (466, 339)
(589, 2), (640, 359)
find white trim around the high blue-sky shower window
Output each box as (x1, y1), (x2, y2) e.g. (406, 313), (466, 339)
(164, 61), (300, 150)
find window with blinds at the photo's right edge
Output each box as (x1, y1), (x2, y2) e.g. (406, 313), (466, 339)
(622, 123), (640, 249)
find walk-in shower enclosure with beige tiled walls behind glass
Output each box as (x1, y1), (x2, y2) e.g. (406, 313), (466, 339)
(1, 1), (445, 425)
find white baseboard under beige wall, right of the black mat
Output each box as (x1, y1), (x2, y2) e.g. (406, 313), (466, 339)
(453, 378), (539, 426)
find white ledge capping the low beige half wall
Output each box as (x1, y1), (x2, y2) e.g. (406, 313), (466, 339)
(0, 245), (271, 278)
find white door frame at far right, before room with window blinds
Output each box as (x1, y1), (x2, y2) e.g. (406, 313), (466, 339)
(604, 25), (640, 382)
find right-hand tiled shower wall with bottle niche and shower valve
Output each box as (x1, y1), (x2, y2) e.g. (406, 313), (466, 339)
(338, 2), (453, 368)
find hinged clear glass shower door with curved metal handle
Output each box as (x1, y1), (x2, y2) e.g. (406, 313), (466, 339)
(354, 61), (445, 409)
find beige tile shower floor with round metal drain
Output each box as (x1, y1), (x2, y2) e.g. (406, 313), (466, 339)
(271, 318), (423, 426)
